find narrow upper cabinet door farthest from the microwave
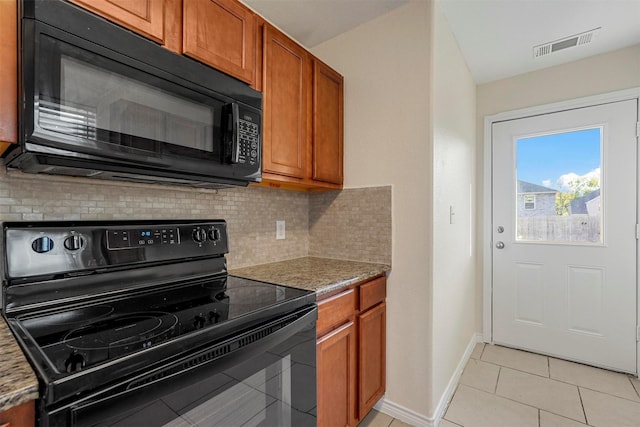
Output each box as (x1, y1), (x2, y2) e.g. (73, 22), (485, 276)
(312, 60), (344, 184)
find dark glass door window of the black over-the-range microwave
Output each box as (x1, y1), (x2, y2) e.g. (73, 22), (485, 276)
(33, 29), (228, 166)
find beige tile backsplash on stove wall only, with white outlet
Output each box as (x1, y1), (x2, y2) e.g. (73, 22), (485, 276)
(0, 168), (309, 268)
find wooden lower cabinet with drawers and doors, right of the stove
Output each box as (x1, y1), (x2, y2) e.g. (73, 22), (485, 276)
(317, 276), (386, 427)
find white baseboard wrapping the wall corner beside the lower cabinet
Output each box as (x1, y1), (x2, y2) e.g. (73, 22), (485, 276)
(374, 333), (482, 427)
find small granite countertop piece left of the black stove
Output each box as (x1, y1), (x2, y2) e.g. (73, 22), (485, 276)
(0, 317), (38, 412)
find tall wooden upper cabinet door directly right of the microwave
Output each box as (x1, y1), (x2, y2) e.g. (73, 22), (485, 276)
(262, 25), (311, 179)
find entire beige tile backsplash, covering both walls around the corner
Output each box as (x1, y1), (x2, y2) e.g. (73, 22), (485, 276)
(0, 167), (391, 268)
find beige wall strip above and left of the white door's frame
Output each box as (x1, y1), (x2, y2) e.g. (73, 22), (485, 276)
(476, 45), (640, 325)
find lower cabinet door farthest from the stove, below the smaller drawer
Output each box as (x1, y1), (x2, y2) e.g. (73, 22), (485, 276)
(358, 303), (386, 419)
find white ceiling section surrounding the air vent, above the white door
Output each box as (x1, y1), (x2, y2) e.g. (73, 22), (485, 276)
(440, 0), (640, 83)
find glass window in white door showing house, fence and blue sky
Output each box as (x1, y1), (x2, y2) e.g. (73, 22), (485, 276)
(516, 127), (602, 243)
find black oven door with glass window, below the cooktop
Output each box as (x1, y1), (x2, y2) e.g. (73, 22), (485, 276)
(47, 308), (317, 427)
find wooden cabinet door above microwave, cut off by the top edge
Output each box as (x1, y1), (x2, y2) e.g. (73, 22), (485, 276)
(71, 0), (165, 44)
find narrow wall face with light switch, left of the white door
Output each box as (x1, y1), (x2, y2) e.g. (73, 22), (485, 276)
(432, 0), (479, 414)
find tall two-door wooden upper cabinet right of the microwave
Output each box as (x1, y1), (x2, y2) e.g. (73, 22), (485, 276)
(256, 23), (344, 191)
